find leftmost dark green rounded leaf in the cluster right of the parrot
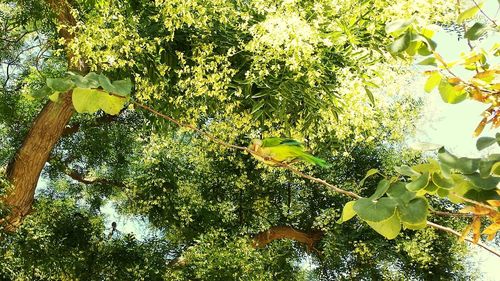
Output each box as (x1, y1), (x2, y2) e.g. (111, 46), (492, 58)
(354, 197), (397, 222)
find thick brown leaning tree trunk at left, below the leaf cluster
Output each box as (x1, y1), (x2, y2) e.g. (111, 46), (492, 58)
(2, 92), (74, 232)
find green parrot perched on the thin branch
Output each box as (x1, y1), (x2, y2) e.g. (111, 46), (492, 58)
(248, 138), (330, 167)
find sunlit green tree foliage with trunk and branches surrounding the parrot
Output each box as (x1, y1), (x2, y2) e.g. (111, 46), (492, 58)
(0, 0), (500, 280)
